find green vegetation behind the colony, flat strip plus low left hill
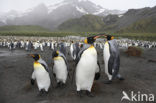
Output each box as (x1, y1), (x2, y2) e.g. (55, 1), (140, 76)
(0, 26), (156, 41)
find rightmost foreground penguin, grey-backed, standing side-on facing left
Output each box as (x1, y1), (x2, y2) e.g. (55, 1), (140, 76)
(103, 35), (124, 84)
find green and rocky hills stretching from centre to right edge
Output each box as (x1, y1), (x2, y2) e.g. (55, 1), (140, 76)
(58, 7), (156, 33)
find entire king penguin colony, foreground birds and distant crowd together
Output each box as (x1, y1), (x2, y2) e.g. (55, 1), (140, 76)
(0, 34), (156, 97)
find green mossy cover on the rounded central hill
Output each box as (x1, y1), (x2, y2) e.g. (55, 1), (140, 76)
(58, 15), (104, 32)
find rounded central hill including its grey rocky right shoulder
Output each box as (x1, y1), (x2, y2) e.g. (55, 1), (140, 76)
(58, 15), (118, 31)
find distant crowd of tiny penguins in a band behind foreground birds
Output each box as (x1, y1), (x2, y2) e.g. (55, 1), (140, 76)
(0, 37), (156, 51)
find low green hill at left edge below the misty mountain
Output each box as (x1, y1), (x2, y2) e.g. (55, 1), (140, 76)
(0, 25), (49, 32)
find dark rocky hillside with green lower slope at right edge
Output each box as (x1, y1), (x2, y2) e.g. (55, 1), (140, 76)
(115, 6), (156, 32)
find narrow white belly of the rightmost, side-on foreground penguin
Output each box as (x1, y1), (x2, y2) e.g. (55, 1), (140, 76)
(103, 42), (112, 80)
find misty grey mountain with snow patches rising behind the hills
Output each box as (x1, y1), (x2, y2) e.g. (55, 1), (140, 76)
(0, 0), (123, 30)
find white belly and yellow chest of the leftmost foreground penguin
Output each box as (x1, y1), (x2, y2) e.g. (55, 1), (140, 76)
(34, 63), (51, 91)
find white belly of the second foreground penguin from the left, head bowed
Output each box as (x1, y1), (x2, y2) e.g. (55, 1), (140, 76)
(53, 57), (68, 83)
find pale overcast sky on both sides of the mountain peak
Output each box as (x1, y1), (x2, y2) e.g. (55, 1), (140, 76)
(0, 0), (156, 12)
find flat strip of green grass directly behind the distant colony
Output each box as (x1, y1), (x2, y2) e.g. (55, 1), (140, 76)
(0, 32), (156, 41)
